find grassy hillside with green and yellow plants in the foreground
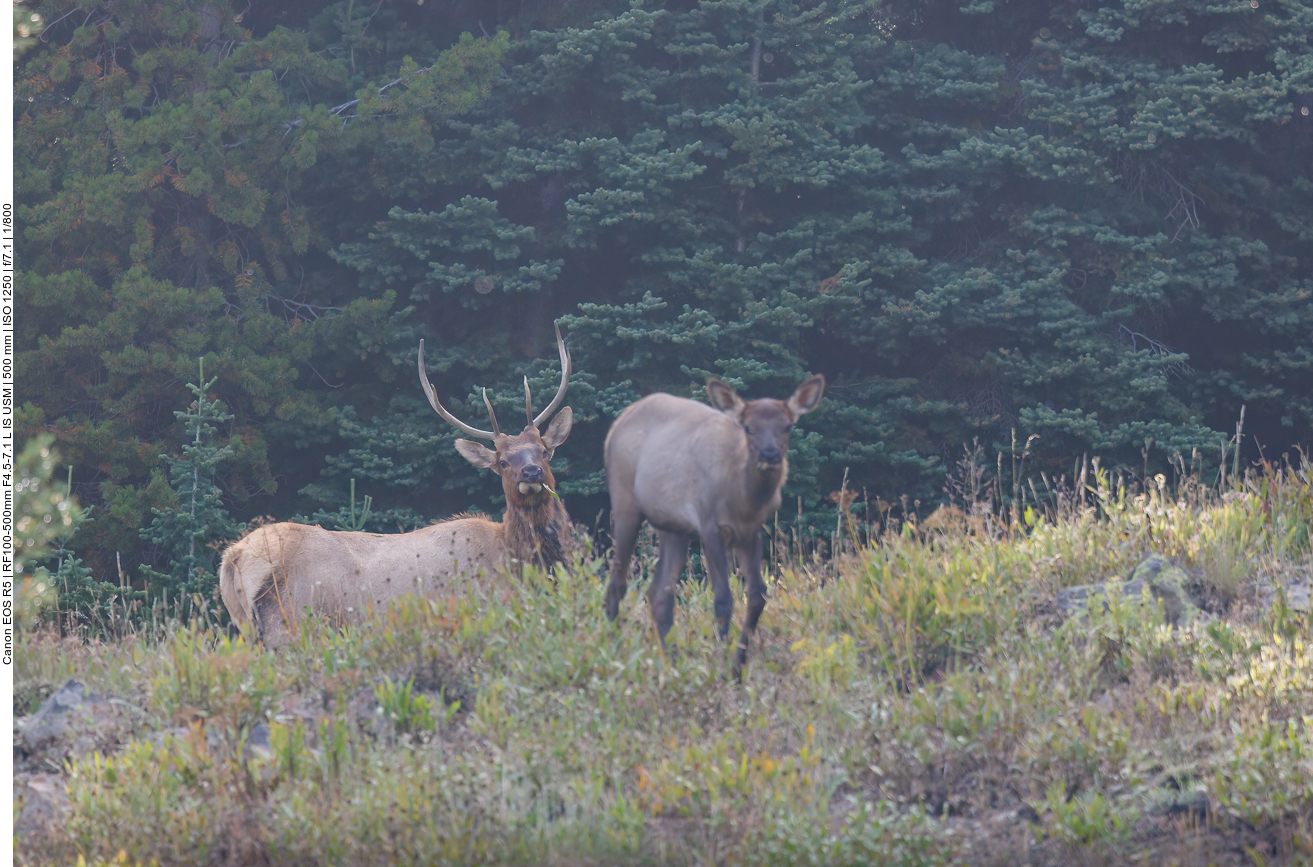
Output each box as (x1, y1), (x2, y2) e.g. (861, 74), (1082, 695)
(16, 457), (1313, 864)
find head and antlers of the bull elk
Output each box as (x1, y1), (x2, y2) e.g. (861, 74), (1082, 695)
(419, 326), (574, 508)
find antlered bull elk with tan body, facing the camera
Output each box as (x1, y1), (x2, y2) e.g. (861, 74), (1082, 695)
(219, 327), (574, 648)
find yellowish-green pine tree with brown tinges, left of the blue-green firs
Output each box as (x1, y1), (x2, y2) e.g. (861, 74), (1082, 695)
(14, 0), (506, 578)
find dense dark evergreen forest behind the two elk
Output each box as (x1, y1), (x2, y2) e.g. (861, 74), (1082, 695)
(13, 0), (1313, 599)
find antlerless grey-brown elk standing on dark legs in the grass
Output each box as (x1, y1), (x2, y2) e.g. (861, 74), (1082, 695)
(605, 374), (825, 678)
